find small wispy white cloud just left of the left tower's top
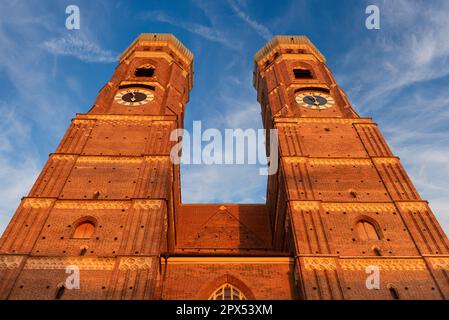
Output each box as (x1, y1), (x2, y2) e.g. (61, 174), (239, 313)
(43, 34), (119, 63)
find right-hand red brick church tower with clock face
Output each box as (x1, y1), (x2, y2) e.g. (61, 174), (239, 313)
(254, 36), (449, 299)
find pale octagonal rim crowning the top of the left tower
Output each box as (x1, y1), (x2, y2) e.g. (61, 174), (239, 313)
(120, 33), (193, 63)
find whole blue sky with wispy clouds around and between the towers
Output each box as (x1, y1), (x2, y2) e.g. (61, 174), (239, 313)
(0, 0), (449, 232)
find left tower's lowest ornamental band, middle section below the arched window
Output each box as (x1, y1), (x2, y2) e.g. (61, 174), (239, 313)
(24, 257), (115, 270)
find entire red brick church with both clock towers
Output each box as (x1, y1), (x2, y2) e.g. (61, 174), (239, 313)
(0, 34), (449, 300)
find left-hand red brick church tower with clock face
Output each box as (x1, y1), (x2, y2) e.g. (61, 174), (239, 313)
(0, 34), (193, 299)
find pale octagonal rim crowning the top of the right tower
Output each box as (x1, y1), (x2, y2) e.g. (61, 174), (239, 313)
(254, 36), (326, 64)
